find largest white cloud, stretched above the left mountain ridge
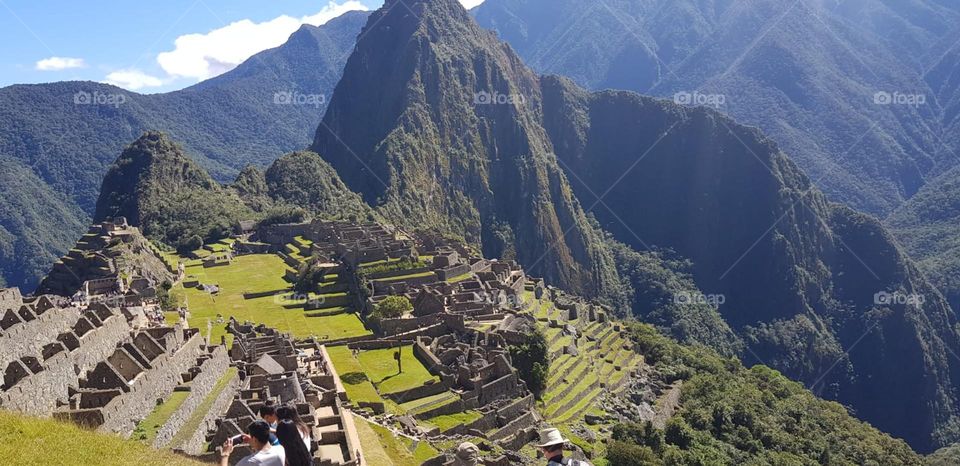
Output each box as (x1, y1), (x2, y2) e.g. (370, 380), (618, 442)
(157, 0), (368, 81)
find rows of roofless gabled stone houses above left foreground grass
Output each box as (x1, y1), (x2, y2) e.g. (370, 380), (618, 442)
(0, 290), (219, 436)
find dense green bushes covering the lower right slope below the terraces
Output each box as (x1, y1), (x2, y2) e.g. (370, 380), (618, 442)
(608, 324), (920, 465)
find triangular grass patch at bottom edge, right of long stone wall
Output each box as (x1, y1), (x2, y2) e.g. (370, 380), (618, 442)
(356, 418), (439, 466)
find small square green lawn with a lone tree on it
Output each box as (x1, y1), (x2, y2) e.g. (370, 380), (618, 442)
(358, 346), (440, 393)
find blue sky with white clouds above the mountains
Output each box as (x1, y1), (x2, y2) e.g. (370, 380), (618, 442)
(0, 0), (482, 93)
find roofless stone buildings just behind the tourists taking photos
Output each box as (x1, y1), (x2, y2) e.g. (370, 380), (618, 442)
(204, 320), (365, 466)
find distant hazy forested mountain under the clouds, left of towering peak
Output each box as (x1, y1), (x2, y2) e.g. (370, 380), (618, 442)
(0, 8), (367, 290)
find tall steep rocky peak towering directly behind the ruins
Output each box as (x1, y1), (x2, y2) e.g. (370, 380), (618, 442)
(313, 0), (615, 296)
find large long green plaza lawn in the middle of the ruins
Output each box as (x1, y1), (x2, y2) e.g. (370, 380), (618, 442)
(171, 254), (371, 342)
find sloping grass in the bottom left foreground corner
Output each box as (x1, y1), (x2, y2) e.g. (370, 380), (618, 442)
(0, 411), (204, 466)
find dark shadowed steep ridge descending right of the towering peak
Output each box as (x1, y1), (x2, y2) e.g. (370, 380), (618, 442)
(542, 77), (960, 450)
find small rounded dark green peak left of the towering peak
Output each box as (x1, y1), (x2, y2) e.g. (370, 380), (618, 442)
(94, 131), (250, 251)
